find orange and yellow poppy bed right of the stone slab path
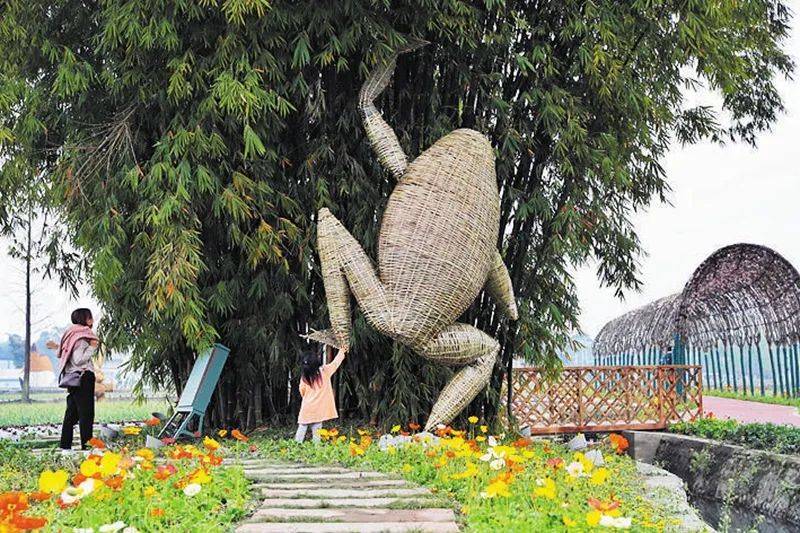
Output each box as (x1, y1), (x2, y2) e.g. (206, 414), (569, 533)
(259, 418), (671, 531)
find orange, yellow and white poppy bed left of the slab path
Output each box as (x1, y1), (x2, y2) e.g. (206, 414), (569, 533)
(0, 426), (249, 533)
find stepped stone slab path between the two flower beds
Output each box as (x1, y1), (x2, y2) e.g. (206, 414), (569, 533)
(228, 459), (459, 533)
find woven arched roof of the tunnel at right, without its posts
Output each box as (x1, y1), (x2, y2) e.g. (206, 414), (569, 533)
(593, 244), (800, 357)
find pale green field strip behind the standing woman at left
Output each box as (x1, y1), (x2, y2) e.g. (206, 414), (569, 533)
(0, 394), (169, 427)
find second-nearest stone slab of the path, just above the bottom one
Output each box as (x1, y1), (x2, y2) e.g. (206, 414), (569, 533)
(249, 507), (456, 523)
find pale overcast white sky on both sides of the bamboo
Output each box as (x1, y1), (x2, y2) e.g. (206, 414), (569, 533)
(0, 23), (800, 339)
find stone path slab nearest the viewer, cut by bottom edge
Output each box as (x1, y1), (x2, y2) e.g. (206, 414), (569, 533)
(236, 522), (458, 533)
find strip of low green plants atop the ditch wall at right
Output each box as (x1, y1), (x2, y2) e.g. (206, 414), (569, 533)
(669, 418), (800, 454)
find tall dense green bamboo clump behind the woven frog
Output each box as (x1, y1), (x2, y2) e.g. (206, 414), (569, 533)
(0, 0), (793, 426)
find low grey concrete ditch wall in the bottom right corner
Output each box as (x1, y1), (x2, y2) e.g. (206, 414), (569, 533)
(623, 431), (800, 530)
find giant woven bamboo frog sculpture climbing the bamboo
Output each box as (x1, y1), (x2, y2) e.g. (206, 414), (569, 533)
(309, 46), (517, 429)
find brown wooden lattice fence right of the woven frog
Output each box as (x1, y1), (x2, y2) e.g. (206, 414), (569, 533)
(503, 365), (703, 435)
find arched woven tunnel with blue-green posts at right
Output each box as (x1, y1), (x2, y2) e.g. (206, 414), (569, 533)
(594, 244), (800, 397)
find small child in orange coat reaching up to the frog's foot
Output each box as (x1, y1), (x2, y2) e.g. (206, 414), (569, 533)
(294, 344), (347, 442)
